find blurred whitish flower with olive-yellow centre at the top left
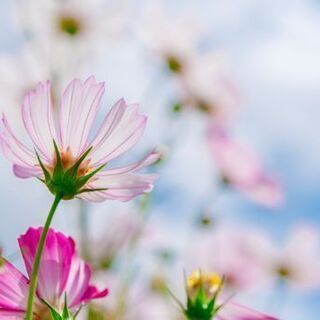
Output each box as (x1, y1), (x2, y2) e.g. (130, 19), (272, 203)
(17, 0), (127, 77)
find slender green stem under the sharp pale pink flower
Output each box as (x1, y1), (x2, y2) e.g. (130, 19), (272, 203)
(25, 194), (62, 320)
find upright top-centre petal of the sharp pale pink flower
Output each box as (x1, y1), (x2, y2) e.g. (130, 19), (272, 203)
(60, 77), (105, 157)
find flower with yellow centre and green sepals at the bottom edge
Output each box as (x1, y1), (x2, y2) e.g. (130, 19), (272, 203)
(184, 270), (276, 320)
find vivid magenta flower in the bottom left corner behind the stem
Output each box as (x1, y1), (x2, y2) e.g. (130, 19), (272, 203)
(0, 228), (108, 320)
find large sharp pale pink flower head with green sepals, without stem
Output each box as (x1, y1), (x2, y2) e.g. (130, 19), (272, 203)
(0, 77), (158, 201)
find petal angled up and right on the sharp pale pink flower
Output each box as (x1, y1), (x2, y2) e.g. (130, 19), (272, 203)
(90, 100), (147, 166)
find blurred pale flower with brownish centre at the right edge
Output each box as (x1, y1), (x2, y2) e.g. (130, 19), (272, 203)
(256, 224), (320, 290)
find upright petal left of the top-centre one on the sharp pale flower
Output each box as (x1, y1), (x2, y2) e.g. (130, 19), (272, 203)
(22, 81), (57, 163)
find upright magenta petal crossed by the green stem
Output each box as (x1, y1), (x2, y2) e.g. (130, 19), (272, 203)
(18, 228), (75, 304)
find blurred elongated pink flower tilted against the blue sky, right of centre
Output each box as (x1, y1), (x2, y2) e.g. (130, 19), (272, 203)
(208, 126), (283, 207)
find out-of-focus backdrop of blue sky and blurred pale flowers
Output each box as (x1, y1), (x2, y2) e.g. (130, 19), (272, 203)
(0, 0), (320, 320)
